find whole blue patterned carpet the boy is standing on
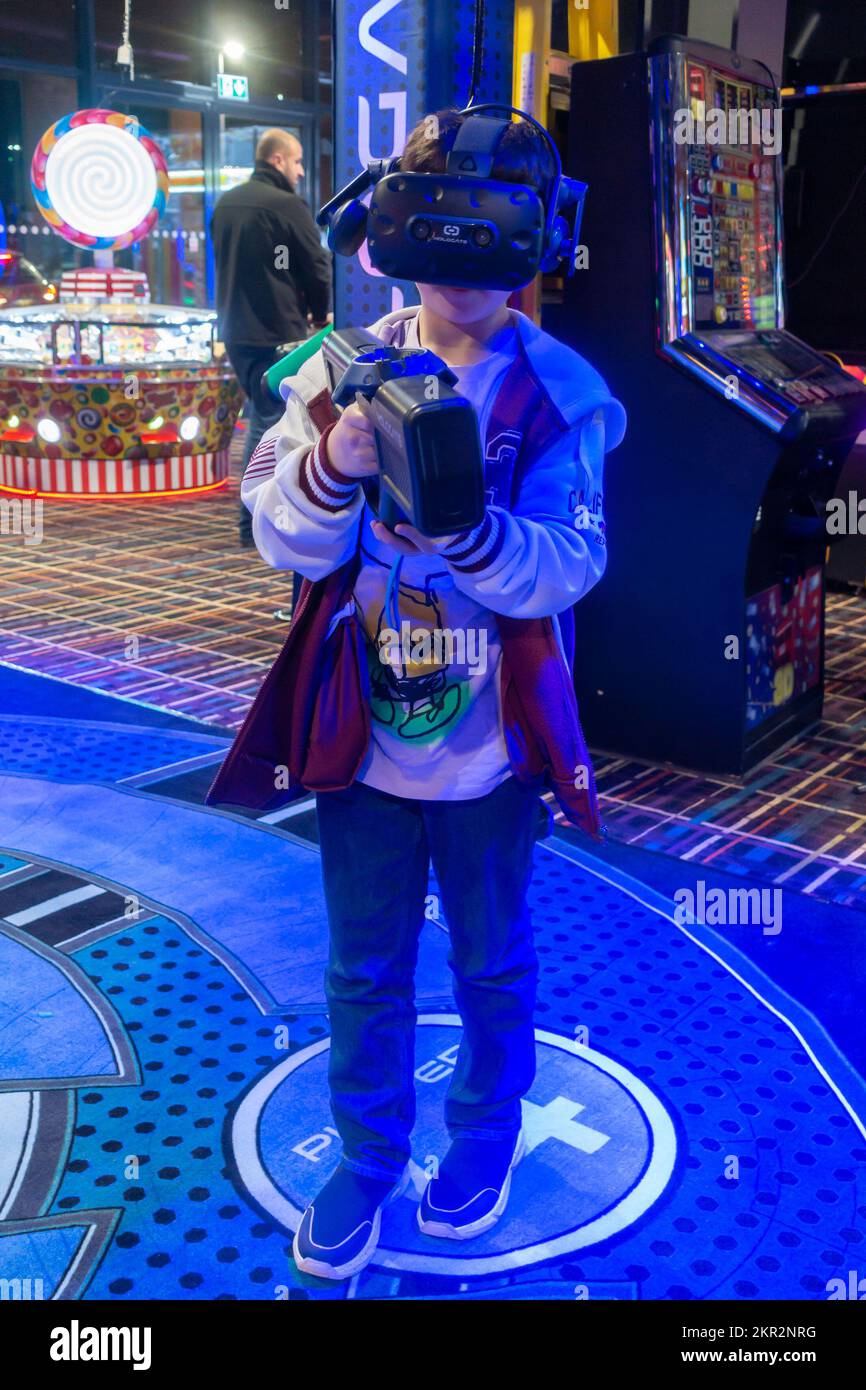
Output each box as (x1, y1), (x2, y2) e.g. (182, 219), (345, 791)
(0, 683), (866, 1302)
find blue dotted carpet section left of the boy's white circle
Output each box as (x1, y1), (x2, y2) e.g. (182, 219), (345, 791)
(54, 917), (327, 1298)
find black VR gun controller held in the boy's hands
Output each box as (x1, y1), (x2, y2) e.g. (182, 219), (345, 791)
(322, 328), (484, 537)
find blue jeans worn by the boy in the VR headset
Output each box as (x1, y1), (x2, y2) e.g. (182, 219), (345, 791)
(316, 777), (538, 1177)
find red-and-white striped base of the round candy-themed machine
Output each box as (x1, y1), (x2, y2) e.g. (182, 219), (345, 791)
(0, 449), (228, 498)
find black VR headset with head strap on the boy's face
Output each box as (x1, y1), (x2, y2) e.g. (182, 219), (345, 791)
(316, 103), (587, 289)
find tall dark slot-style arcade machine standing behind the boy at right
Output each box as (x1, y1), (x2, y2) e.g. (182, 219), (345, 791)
(555, 39), (866, 774)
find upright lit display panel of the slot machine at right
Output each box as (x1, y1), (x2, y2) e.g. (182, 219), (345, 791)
(685, 57), (777, 331)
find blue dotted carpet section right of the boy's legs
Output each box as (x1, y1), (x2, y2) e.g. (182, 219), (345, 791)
(534, 849), (866, 1300)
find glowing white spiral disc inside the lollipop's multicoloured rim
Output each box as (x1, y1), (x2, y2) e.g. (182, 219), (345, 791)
(44, 124), (157, 238)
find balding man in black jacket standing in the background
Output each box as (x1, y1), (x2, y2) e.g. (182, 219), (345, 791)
(211, 129), (331, 545)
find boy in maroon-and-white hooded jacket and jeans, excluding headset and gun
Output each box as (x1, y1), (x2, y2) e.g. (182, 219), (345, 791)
(209, 108), (626, 1279)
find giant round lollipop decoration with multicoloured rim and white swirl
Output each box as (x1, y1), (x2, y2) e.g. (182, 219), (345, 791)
(31, 108), (168, 252)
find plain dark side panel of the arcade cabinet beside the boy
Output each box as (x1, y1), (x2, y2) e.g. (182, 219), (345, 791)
(557, 54), (762, 771)
